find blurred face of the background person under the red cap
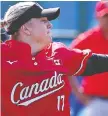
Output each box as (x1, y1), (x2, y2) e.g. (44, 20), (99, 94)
(98, 14), (108, 30)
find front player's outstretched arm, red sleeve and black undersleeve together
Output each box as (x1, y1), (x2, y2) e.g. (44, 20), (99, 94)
(60, 49), (108, 76)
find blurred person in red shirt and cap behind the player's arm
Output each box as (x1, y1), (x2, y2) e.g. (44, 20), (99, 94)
(70, 1), (108, 116)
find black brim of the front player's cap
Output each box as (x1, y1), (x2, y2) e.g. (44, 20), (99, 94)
(41, 7), (60, 21)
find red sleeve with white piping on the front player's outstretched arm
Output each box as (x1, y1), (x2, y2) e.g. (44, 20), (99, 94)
(55, 48), (92, 76)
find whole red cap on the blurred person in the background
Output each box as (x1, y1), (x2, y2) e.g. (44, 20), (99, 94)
(96, 1), (108, 17)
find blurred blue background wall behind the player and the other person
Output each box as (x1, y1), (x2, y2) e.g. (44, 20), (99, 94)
(0, 1), (97, 116)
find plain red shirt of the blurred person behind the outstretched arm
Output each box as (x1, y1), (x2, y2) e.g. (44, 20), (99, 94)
(70, 27), (108, 97)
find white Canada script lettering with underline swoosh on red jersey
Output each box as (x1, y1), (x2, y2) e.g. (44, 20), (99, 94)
(11, 71), (65, 106)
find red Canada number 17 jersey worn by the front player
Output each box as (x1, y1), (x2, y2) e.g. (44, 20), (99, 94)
(1, 40), (91, 116)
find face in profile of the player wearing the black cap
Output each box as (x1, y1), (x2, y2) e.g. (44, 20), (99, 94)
(30, 17), (52, 45)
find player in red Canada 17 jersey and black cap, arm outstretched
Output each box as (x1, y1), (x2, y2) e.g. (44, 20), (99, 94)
(1, 2), (108, 116)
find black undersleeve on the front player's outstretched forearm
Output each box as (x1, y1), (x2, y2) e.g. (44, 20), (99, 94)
(81, 53), (108, 76)
